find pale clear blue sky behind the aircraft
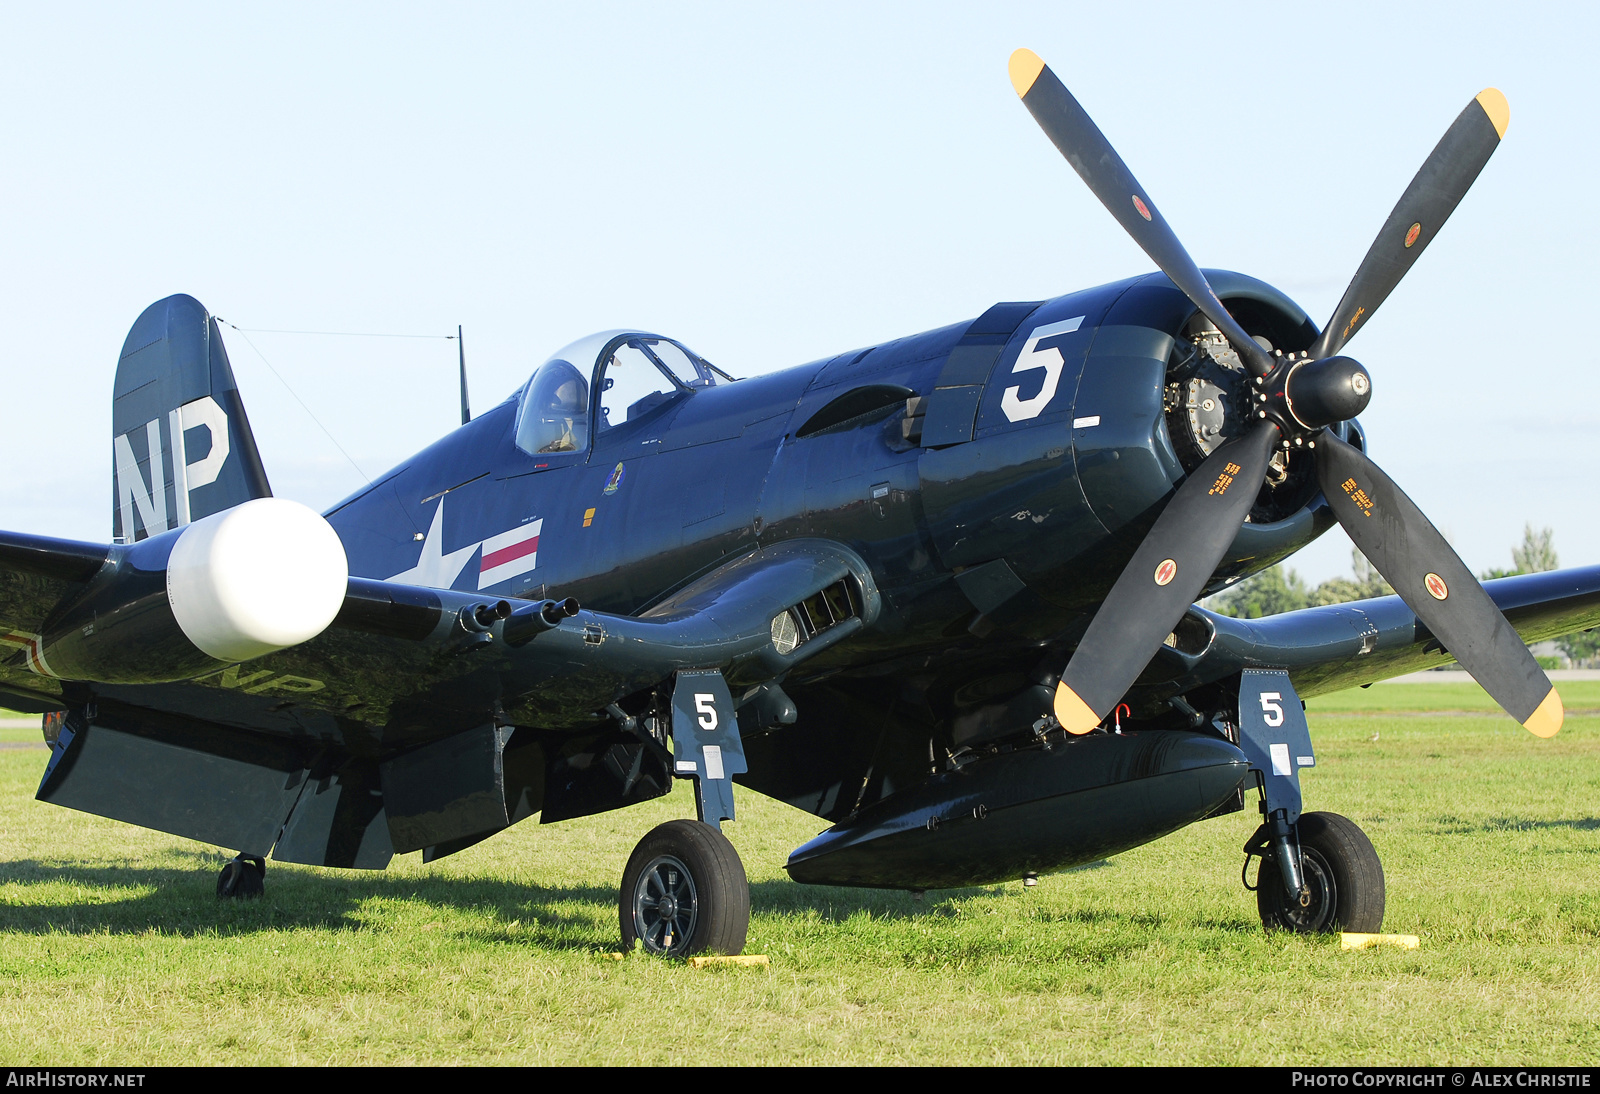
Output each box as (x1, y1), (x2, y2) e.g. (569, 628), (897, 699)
(0, 3), (1600, 581)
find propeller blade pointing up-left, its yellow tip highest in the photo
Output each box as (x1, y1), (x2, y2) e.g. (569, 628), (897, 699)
(1011, 50), (1272, 377)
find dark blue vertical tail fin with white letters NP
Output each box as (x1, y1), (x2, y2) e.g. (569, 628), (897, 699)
(110, 296), (272, 544)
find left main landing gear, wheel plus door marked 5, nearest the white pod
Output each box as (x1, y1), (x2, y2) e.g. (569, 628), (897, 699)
(618, 672), (750, 958)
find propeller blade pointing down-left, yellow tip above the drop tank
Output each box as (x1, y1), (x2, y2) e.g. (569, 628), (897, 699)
(1054, 421), (1278, 733)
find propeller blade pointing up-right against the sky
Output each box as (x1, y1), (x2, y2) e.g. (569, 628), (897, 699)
(1310, 88), (1510, 357)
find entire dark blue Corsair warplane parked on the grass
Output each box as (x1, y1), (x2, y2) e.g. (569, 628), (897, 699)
(0, 50), (1600, 955)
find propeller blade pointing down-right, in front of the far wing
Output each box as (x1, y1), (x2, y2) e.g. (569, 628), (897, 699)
(1317, 433), (1565, 737)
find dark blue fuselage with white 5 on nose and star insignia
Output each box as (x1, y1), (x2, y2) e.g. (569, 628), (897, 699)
(328, 272), (1331, 684)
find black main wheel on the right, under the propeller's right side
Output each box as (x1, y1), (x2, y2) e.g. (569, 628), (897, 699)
(1256, 813), (1384, 934)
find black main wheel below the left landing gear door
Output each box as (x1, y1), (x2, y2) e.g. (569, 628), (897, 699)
(619, 821), (750, 956)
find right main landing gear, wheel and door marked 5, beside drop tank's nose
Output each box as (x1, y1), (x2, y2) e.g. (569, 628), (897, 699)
(1238, 669), (1384, 934)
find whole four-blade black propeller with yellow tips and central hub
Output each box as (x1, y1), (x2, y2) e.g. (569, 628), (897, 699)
(1011, 50), (1563, 737)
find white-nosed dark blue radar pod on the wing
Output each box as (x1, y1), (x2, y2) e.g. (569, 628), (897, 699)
(37, 497), (349, 683)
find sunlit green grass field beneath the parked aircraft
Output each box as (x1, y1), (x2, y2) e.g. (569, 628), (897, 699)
(0, 681), (1600, 1065)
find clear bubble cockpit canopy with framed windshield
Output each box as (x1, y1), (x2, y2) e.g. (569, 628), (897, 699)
(517, 331), (733, 456)
